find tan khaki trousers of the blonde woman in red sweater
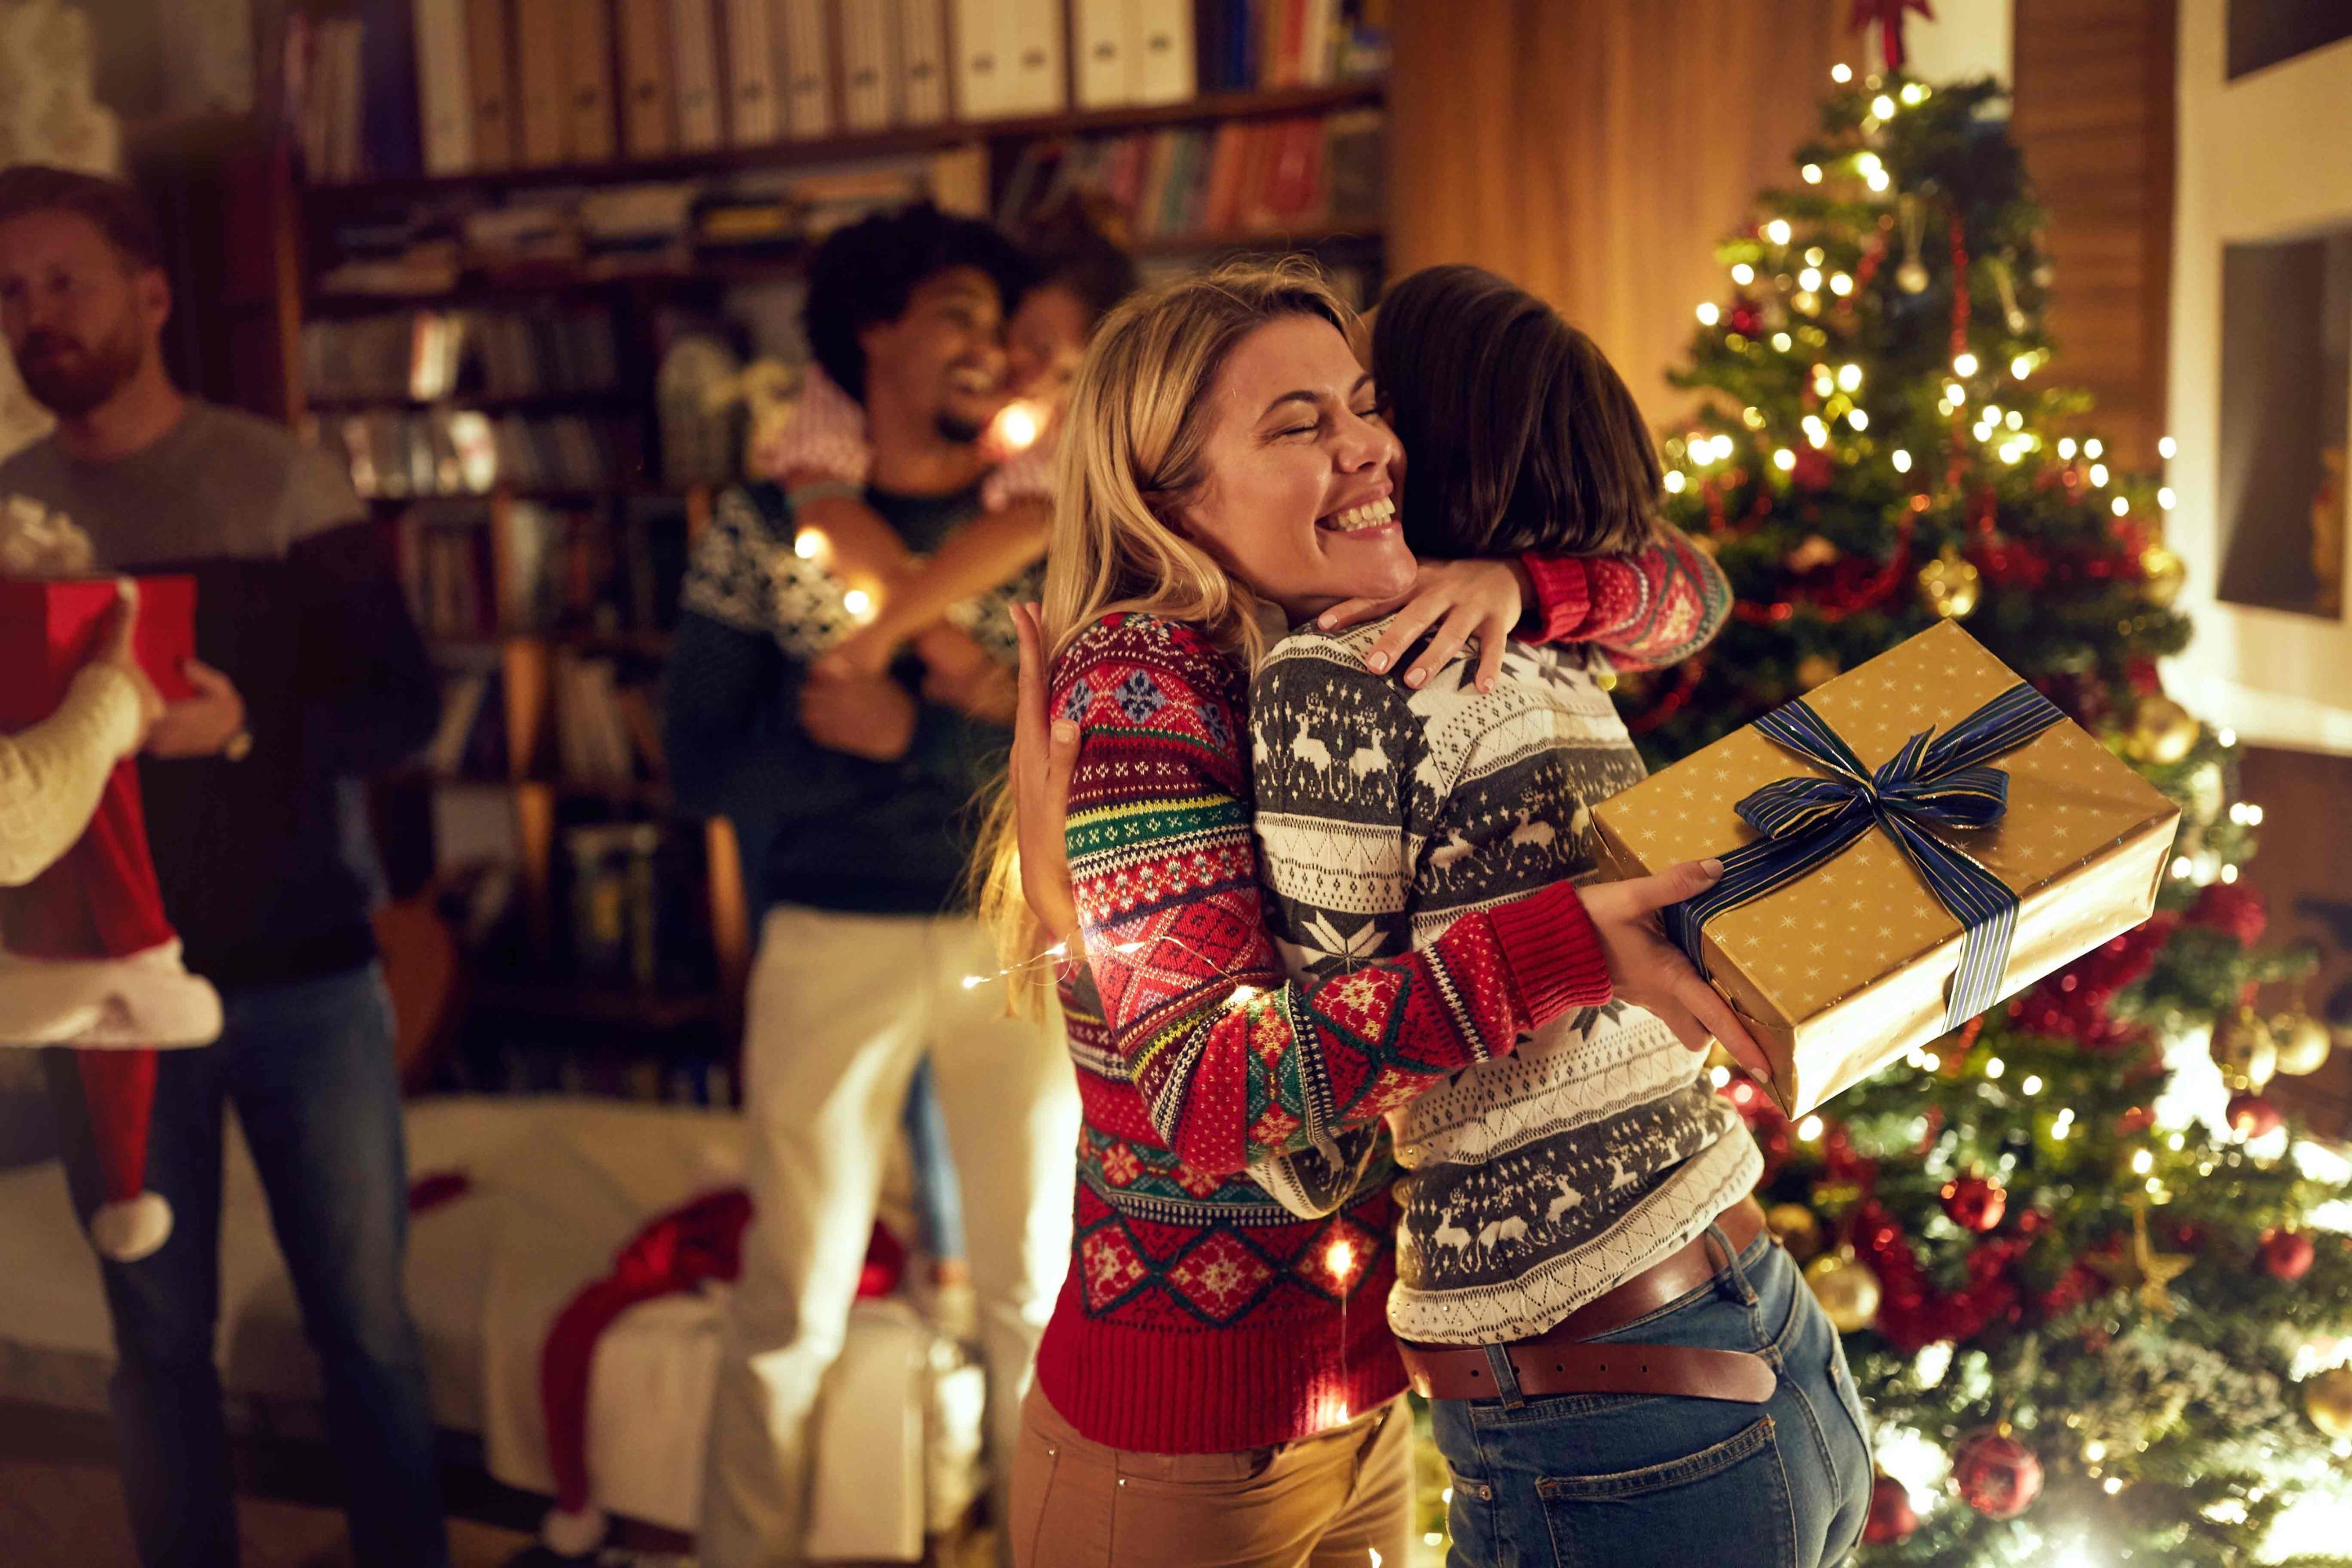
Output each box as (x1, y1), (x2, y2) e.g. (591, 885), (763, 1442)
(1009, 1387), (1414, 1568)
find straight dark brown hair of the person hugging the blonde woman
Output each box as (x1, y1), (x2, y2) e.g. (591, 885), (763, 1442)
(1371, 266), (1661, 557)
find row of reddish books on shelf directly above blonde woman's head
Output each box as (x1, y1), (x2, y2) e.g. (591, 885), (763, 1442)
(997, 108), (1385, 240)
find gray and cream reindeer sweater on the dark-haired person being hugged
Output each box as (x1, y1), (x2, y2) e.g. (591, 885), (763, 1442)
(1249, 623), (1764, 1345)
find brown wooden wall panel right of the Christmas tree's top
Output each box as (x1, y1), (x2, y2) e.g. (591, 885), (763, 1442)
(2011, 0), (2178, 468)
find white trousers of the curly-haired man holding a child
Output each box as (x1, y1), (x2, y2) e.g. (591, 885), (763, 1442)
(701, 905), (1080, 1568)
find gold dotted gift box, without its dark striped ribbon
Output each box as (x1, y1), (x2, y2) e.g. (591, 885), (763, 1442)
(1592, 621), (2180, 1116)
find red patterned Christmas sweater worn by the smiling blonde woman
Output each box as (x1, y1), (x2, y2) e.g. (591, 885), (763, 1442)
(1037, 614), (1609, 1453)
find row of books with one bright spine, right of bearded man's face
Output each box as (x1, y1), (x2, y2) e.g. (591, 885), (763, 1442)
(301, 308), (621, 402)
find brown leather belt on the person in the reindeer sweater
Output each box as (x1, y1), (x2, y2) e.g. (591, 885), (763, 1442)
(1397, 1199), (1780, 1403)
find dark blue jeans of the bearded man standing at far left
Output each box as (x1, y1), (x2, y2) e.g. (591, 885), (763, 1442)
(47, 964), (449, 1568)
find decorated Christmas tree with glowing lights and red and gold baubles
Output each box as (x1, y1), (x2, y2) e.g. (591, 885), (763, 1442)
(1621, 68), (2352, 1566)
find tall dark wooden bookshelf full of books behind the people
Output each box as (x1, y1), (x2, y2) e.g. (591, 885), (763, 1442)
(270, 0), (1385, 1098)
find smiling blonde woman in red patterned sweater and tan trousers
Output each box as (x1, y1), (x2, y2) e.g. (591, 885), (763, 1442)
(997, 266), (1740, 1568)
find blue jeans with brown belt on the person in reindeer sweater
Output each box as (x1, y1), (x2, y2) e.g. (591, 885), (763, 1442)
(1430, 1232), (1870, 1568)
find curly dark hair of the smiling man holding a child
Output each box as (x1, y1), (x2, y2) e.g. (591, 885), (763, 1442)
(800, 202), (1037, 402)
